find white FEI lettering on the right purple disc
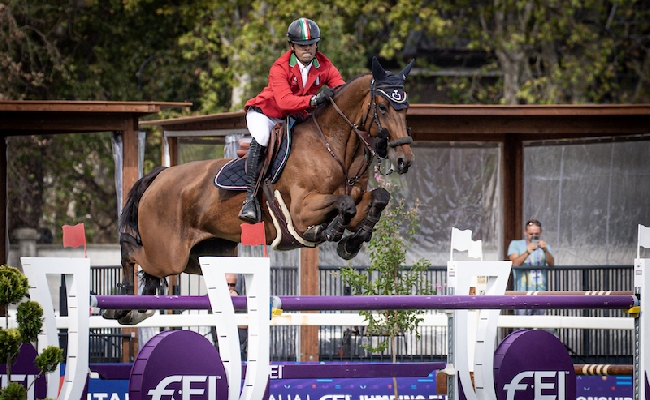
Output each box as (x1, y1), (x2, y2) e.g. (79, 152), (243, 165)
(503, 371), (566, 400)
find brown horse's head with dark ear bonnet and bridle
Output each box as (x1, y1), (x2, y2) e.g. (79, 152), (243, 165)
(364, 57), (415, 174)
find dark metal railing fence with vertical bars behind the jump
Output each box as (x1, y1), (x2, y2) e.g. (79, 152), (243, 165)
(82, 265), (634, 364)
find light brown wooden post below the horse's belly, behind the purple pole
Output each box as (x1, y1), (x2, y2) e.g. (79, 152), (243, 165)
(300, 248), (319, 362)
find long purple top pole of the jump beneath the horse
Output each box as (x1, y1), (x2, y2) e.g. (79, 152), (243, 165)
(94, 295), (638, 311)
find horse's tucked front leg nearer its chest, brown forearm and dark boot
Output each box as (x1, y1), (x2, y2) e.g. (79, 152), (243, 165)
(292, 195), (357, 243)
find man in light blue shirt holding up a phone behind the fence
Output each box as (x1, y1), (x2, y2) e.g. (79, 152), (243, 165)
(508, 219), (555, 315)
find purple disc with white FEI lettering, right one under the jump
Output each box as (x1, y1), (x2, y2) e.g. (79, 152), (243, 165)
(494, 330), (576, 400)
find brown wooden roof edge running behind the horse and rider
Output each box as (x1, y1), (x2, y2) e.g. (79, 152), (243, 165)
(140, 104), (650, 142)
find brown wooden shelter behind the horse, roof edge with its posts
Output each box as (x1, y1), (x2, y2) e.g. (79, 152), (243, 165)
(142, 104), (650, 361)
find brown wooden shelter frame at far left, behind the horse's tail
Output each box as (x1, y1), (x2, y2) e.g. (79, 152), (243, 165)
(0, 100), (191, 264)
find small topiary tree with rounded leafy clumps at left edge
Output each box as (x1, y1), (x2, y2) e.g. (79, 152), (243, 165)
(0, 265), (63, 400)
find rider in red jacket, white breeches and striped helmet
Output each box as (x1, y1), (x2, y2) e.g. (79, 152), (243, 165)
(239, 18), (345, 223)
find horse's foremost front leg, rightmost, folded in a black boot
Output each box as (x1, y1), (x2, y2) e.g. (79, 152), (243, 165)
(336, 188), (390, 260)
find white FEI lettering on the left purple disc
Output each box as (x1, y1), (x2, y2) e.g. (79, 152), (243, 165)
(147, 375), (217, 400)
